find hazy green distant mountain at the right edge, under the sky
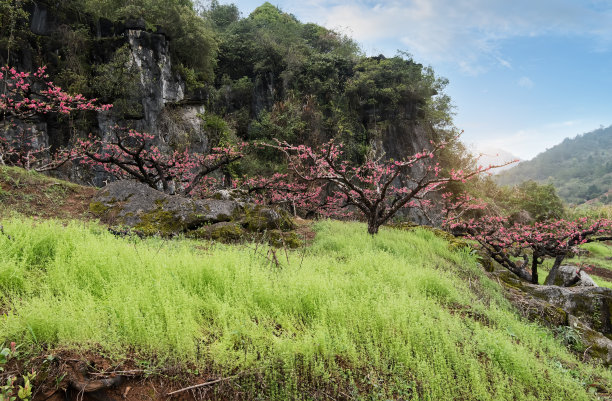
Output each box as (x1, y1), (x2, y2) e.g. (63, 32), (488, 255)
(496, 126), (612, 204)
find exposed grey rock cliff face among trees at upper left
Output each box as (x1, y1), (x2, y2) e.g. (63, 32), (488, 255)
(6, 1), (209, 185)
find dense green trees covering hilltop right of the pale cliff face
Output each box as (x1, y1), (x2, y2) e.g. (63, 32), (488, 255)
(205, 3), (455, 173)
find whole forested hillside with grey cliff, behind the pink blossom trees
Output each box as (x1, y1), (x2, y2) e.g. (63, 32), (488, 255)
(0, 0), (460, 178)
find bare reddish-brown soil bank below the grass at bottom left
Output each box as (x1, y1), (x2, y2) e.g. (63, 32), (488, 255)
(0, 351), (248, 401)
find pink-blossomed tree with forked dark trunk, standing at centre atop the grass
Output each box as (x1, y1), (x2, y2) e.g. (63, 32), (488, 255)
(269, 138), (510, 233)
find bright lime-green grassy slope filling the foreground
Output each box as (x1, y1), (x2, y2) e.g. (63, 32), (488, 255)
(0, 218), (612, 400)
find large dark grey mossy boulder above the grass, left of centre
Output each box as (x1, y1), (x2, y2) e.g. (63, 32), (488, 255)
(90, 180), (242, 236)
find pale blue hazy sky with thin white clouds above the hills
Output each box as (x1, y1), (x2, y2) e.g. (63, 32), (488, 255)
(221, 0), (612, 159)
